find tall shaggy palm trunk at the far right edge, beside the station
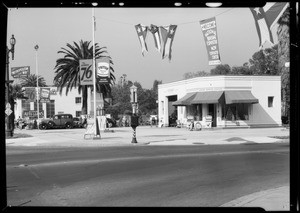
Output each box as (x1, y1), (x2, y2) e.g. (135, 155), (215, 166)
(277, 8), (290, 120)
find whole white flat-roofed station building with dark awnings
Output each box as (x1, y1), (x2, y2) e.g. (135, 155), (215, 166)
(158, 76), (281, 128)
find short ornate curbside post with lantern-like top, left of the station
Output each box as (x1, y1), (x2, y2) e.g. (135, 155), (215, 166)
(130, 85), (139, 143)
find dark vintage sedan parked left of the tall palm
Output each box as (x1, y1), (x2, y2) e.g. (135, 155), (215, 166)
(39, 114), (74, 129)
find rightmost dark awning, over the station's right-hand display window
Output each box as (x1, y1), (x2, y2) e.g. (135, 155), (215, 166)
(225, 90), (258, 104)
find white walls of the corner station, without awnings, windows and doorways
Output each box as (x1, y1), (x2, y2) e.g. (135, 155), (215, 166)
(158, 76), (281, 127)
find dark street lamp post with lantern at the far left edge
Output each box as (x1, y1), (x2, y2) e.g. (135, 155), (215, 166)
(5, 35), (16, 137)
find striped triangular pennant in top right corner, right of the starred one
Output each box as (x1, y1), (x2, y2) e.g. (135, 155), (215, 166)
(263, 2), (289, 29)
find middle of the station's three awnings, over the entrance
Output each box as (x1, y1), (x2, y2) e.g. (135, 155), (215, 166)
(191, 91), (224, 104)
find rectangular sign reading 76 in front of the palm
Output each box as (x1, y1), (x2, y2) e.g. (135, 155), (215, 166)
(79, 59), (93, 85)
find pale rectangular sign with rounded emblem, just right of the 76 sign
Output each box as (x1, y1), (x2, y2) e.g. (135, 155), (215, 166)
(96, 57), (110, 84)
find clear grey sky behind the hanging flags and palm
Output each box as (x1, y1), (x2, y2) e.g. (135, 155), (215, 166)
(7, 5), (276, 89)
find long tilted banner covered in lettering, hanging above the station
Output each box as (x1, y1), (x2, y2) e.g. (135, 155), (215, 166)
(200, 17), (221, 65)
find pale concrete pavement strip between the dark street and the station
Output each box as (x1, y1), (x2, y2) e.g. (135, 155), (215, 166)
(6, 126), (289, 147)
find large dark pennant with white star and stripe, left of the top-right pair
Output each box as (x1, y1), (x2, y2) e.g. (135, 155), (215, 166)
(250, 7), (273, 49)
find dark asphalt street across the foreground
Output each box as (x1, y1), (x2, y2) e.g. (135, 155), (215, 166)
(6, 143), (290, 207)
